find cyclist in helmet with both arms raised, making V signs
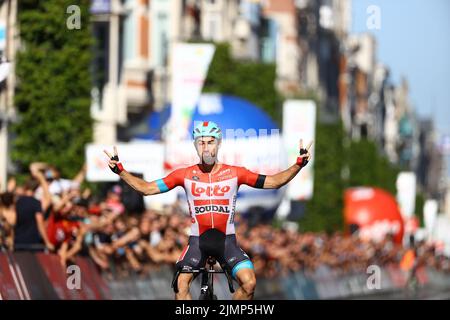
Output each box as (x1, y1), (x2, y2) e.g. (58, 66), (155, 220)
(104, 121), (312, 300)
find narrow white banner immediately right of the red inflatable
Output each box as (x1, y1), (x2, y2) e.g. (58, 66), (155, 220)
(396, 172), (416, 218)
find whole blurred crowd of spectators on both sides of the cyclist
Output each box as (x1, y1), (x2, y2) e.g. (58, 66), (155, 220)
(0, 163), (450, 278)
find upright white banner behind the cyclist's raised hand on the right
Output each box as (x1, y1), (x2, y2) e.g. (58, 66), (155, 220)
(283, 100), (316, 200)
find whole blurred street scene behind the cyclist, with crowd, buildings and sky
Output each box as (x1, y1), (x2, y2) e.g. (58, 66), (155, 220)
(0, 0), (450, 299)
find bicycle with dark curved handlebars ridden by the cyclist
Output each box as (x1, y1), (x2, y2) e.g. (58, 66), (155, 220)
(172, 256), (234, 300)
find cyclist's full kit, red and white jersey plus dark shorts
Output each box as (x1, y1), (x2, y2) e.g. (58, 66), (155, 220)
(156, 164), (266, 277)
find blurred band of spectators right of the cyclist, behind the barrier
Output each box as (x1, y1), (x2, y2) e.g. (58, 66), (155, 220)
(237, 222), (450, 278)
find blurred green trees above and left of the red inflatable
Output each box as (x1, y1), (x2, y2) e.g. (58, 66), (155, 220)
(299, 122), (400, 232)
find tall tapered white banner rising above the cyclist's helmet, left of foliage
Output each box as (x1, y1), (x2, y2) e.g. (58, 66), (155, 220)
(167, 43), (215, 141)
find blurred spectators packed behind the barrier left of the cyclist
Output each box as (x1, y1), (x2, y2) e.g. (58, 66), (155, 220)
(0, 163), (189, 275)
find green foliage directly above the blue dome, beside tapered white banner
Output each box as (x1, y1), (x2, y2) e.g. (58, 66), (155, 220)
(203, 43), (282, 124)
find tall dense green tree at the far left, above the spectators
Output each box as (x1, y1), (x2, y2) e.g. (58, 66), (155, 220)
(12, 0), (93, 176)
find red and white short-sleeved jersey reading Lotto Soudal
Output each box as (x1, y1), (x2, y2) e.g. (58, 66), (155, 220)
(156, 164), (265, 236)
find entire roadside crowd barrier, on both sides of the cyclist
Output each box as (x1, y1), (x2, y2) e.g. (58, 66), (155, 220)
(0, 252), (450, 300)
